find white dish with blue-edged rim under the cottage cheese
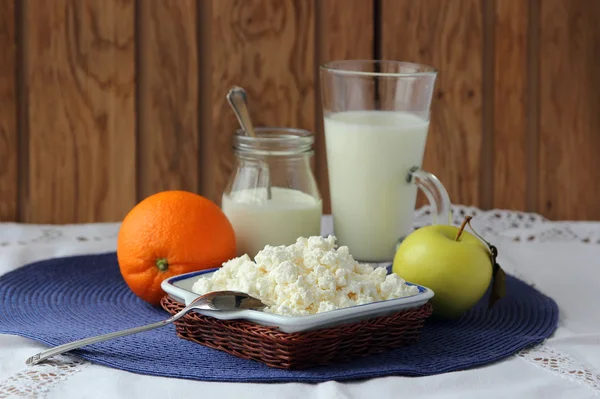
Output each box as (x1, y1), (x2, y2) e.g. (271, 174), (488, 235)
(161, 269), (434, 333)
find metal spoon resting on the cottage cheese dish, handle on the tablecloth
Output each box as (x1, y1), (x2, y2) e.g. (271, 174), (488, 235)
(25, 291), (266, 365)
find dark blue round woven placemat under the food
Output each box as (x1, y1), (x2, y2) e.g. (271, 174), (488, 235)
(0, 253), (558, 382)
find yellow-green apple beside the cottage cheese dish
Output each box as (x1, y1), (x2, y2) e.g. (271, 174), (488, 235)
(392, 225), (492, 318)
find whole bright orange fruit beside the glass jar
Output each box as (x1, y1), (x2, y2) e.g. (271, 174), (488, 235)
(117, 191), (236, 305)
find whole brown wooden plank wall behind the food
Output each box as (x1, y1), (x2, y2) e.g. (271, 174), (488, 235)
(0, 0), (600, 223)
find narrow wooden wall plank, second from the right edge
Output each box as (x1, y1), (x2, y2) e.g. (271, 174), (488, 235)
(493, 0), (535, 210)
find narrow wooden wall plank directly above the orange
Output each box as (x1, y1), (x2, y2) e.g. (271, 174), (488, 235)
(137, 0), (198, 199)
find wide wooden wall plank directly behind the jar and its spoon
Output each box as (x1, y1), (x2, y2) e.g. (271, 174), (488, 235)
(202, 0), (315, 204)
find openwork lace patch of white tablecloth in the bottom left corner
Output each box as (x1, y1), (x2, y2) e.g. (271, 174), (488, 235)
(0, 355), (90, 399)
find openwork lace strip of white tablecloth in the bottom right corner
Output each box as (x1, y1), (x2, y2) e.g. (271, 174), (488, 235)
(517, 344), (600, 393)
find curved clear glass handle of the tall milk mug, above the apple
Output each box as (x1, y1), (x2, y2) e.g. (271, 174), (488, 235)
(406, 166), (452, 224)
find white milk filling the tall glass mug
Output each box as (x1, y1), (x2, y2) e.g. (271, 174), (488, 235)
(324, 110), (429, 262)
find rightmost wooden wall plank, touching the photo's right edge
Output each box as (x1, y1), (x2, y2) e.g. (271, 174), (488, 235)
(538, 0), (600, 220)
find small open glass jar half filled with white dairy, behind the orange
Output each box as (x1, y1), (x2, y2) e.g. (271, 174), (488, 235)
(221, 127), (322, 258)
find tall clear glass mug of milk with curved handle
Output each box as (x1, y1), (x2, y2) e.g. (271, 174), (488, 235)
(320, 60), (450, 262)
